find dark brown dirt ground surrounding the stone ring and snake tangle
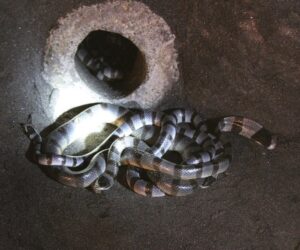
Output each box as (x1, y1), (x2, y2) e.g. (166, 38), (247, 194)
(0, 0), (300, 250)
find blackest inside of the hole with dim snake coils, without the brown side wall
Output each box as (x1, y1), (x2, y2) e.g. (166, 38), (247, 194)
(75, 31), (136, 83)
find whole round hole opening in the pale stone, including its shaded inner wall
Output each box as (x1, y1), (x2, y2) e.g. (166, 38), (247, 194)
(75, 30), (147, 98)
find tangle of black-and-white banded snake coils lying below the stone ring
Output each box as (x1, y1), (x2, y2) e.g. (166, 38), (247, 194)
(23, 103), (276, 197)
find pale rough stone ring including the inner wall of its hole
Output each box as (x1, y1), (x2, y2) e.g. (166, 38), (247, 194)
(41, 0), (179, 111)
